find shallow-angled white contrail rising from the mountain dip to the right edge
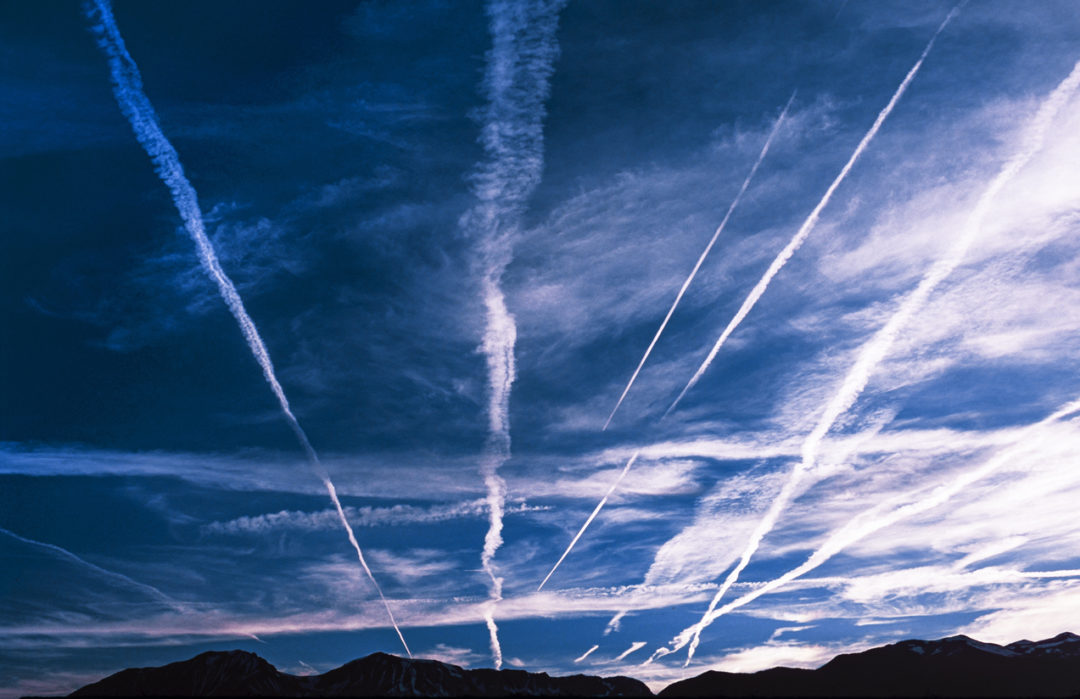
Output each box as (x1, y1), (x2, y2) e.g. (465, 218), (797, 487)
(646, 400), (1080, 663)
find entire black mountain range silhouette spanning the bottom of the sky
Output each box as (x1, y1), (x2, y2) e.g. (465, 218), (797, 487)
(61, 633), (1080, 697)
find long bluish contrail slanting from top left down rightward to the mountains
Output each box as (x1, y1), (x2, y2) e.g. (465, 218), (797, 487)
(86, 0), (413, 657)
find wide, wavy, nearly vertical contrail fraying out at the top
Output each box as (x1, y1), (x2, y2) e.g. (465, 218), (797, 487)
(461, 0), (564, 669)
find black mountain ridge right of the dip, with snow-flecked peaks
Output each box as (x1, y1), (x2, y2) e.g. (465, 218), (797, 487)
(659, 633), (1080, 697)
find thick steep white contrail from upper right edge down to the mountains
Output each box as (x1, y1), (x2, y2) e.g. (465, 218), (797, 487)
(673, 50), (1080, 662)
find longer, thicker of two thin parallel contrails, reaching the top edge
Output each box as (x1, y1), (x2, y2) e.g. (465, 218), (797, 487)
(664, 5), (960, 417)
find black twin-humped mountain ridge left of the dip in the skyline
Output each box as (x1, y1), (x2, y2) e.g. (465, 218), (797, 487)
(70, 650), (652, 697)
